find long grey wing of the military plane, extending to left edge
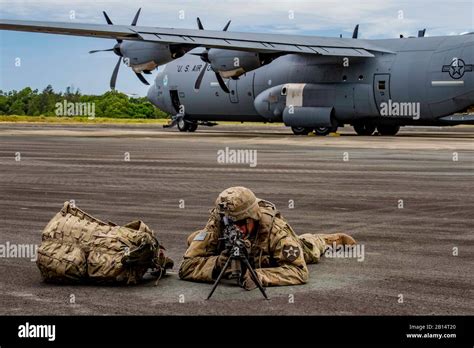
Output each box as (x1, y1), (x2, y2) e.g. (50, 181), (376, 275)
(0, 19), (393, 58)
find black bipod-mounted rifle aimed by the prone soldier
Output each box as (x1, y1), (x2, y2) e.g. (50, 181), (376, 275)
(207, 215), (268, 300)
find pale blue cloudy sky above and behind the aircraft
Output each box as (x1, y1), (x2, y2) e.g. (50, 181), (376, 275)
(0, 0), (474, 96)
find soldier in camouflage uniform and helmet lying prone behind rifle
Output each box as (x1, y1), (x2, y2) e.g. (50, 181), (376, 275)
(179, 187), (356, 290)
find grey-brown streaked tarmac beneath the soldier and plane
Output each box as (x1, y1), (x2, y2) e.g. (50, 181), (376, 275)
(0, 124), (474, 315)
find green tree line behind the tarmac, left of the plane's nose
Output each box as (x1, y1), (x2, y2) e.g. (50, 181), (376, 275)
(0, 85), (168, 118)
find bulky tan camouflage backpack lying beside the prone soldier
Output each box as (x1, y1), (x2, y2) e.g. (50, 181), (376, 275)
(37, 202), (173, 284)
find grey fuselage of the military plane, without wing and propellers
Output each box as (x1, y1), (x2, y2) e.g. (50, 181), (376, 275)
(148, 34), (474, 126)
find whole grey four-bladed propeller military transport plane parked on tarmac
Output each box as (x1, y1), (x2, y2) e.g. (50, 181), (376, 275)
(0, 10), (474, 135)
